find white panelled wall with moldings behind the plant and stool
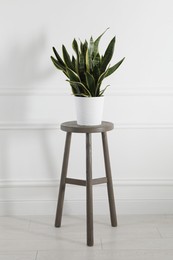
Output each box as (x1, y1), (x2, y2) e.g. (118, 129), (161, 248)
(0, 0), (173, 214)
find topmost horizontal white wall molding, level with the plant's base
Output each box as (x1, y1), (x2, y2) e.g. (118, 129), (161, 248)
(0, 86), (173, 96)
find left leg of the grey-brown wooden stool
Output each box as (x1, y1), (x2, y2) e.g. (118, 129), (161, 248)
(55, 133), (71, 227)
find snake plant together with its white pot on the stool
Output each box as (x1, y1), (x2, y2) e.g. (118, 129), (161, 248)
(51, 29), (124, 125)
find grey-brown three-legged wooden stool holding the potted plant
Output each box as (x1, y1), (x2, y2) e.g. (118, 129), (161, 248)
(55, 121), (117, 246)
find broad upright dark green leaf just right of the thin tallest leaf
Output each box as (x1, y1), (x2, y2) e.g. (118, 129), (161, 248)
(101, 37), (115, 72)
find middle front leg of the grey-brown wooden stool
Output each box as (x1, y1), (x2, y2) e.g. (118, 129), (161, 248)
(86, 133), (94, 246)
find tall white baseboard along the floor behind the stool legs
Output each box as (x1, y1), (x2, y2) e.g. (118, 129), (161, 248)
(0, 180), (173, 215)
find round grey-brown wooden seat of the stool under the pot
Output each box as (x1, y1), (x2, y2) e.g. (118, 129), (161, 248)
(61, 121), (114, 133)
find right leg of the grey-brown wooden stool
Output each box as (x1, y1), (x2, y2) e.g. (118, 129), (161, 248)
(102, 132), (117, 227)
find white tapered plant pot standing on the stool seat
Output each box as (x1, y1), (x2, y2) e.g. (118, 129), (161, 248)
(74, 96), (104, 125)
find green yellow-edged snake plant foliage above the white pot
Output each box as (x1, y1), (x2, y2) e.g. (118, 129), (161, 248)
(51, 30), (124, 97)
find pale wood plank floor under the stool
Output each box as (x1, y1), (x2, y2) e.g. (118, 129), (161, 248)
(0, 215), (173, 260)
